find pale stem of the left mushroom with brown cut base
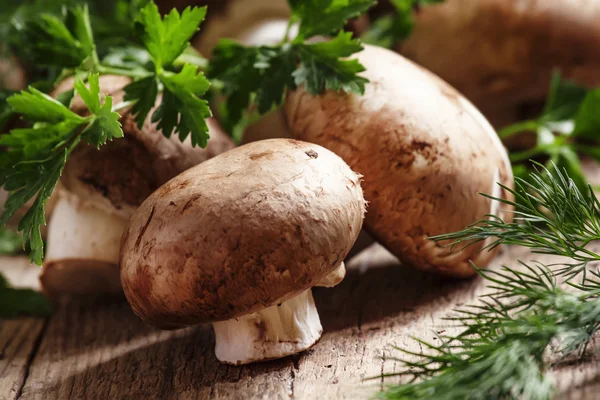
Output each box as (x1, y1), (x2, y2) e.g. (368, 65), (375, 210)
(40, 191), (127, 294)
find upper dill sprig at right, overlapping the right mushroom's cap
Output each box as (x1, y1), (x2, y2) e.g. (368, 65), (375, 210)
(431, 163), (600, 278)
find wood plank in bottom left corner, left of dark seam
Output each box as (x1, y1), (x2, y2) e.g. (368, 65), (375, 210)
(0, 257), (45, 400)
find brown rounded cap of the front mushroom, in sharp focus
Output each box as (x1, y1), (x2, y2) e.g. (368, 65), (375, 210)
(120, 139), (365, 328)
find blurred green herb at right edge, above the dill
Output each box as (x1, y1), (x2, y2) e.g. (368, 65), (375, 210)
(499, 74), (600, 194)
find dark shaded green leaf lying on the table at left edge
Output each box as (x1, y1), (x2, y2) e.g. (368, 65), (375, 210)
(0, 275), (52, 318)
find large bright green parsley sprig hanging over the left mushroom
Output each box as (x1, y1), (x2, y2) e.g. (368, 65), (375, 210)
(0, 2), (210, 264)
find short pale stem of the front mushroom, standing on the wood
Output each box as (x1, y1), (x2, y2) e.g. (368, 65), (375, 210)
(213, 289), (323, 365)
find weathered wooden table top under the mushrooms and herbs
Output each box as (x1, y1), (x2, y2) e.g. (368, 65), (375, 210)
(0, 245), (600, 399)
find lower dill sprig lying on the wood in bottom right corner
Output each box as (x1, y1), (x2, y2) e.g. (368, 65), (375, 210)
(380, 265), (600, 400)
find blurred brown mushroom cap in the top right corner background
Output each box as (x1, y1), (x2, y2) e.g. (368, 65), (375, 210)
(398, 0), (600, 122)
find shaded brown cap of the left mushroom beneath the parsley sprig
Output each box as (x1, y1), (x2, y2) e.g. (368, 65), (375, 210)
(52, 75), (234, 218)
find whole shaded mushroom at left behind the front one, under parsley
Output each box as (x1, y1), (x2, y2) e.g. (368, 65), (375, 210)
(40, 75), (233, 294)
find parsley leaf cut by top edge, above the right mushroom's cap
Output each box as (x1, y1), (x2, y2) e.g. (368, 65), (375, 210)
(290, 0), (377, 39)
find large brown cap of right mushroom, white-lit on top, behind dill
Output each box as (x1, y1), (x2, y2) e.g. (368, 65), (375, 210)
(285, 46), (513, 277)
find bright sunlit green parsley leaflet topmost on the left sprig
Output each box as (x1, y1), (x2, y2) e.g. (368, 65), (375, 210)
(136, 2), (206, 68)
